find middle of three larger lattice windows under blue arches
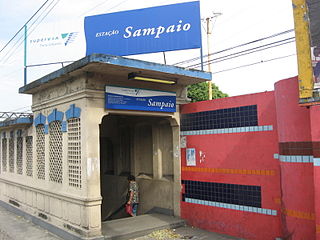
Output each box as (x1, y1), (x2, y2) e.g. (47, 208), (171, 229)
(49, 121), (62, 183)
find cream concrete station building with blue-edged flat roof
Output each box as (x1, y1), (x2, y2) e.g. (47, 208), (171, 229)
(0, 55), (211, 239)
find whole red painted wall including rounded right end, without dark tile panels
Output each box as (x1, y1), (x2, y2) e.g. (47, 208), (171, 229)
(181, 77), (320, 240)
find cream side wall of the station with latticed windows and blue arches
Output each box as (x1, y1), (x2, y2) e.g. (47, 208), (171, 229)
(0, 104), (100, 238)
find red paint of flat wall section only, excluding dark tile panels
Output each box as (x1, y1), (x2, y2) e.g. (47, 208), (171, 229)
(181, 92), (281, 239)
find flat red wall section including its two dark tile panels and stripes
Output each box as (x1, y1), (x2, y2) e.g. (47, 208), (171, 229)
(181, 92), (281, 240)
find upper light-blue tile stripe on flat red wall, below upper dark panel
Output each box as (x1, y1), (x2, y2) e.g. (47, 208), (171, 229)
(180, 125), (273, 136)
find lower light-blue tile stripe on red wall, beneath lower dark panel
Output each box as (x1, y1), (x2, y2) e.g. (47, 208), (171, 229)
(185, 198), (277, 216)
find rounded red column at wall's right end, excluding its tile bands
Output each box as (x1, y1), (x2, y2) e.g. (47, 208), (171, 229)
(275, 78), (315, 239)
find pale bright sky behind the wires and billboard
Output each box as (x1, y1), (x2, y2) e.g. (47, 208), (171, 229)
(0, 0), (297, 112)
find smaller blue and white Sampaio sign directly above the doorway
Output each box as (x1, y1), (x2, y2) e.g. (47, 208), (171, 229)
(105, 86), (176, 112)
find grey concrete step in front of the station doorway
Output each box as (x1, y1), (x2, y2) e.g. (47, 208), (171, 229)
(102, 213), (186, 240)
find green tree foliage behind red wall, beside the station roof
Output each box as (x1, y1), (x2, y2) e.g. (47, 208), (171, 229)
(188, 82), (228, 102)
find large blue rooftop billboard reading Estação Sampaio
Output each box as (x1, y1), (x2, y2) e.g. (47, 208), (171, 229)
(84, 1), (201, 56)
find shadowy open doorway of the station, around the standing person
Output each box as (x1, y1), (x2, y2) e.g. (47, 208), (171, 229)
(100, 114), (174, 221)
